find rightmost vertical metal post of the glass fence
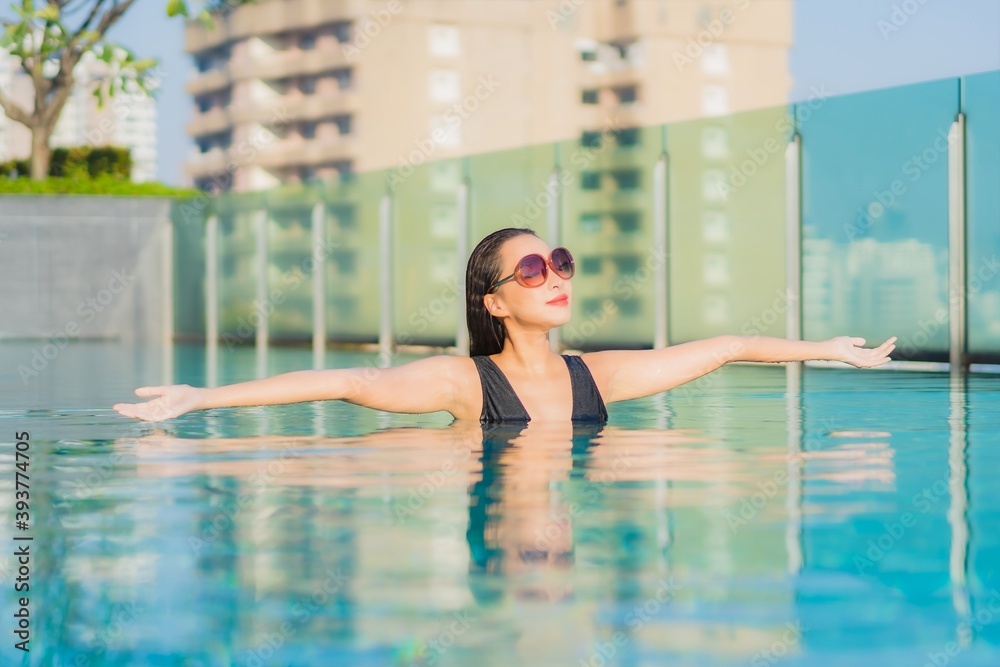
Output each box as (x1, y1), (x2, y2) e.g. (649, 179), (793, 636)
(948, 113), (967, 373)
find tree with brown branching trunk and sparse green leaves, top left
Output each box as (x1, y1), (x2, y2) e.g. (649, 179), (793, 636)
(0, 0), (253, 181)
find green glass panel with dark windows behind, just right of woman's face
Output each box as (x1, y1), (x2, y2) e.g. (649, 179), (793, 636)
(558, 126), (663, 350)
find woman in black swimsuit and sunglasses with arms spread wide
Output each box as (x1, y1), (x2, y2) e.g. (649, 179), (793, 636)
(114, 228), (896, 423)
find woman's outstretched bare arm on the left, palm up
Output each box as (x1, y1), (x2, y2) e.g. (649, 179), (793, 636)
(114, 355), (465, 421)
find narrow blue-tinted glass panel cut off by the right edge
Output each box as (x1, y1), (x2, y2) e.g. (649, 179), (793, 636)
(962, 72), (1000, 363)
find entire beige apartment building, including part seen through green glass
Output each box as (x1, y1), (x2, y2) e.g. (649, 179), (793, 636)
(186, 0), (792, 349)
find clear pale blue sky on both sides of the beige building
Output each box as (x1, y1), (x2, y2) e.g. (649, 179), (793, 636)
(112, 0), (1000, 183)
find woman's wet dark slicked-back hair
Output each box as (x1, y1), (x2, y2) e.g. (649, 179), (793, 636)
(465, 227), (538, 357)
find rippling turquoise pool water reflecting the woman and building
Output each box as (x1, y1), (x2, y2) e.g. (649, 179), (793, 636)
(0, 343), (1000, 667)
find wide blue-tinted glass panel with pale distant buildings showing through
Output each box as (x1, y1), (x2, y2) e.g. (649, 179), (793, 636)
(798, 79), (958, 360)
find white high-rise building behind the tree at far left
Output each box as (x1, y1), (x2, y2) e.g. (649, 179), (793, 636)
(0, 49), (157, 181)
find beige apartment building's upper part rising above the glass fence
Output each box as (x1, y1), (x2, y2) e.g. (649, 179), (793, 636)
(186, 0), (792, 191)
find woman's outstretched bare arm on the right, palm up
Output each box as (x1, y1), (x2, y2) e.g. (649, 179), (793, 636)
(582, 335), (896, 403)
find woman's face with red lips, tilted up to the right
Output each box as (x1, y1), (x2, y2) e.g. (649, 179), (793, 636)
(486, 234), (573, 328)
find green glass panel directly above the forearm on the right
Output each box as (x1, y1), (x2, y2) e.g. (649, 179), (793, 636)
(667, 106), (791, 344)
